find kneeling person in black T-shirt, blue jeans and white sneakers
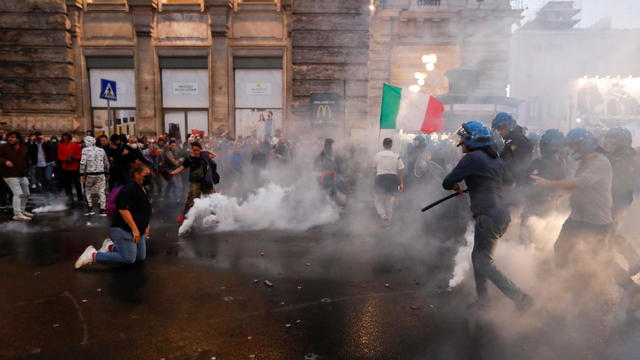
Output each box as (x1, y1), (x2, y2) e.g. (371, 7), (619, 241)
(75, 164), (152, 269)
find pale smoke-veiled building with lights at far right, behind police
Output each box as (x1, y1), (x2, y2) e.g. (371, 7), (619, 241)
(510, 1), (640, 131)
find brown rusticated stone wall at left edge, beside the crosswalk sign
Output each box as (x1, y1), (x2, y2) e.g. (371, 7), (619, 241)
(0, 0), (78, 133)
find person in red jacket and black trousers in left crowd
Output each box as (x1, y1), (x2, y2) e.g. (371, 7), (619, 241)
(58, 133), (84, 204)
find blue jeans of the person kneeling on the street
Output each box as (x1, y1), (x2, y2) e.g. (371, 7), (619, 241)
(96, 227), (147, 264)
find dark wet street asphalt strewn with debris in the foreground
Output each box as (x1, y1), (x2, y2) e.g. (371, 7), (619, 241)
(0, 200), (639, 360)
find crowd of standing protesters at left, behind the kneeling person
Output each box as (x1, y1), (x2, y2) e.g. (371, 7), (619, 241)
(0, 130), (292, 221)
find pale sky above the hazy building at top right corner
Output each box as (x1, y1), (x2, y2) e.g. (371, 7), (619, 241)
(524, 0), (640, 29)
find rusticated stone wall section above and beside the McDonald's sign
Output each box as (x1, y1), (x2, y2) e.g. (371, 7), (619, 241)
(291, 0), (370, 134)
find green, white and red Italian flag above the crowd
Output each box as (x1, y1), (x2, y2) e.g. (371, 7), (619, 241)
(380, 84), (444, 133)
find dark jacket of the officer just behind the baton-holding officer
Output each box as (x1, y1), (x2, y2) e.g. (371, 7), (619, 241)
(500, 126), (533, 185)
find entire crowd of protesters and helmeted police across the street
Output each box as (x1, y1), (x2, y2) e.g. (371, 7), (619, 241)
(0, 113), (640, 310)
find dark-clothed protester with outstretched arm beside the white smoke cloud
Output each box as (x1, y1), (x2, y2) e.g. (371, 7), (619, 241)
(171, 142), (219, 222)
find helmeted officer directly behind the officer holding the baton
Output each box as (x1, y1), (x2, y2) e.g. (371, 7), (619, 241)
(491, 112), (533, 187)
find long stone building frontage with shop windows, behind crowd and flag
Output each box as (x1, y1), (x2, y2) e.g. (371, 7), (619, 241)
(0, 0), (520, 138)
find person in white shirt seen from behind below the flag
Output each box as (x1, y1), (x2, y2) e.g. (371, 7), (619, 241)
(374, 138), (404, 227)
